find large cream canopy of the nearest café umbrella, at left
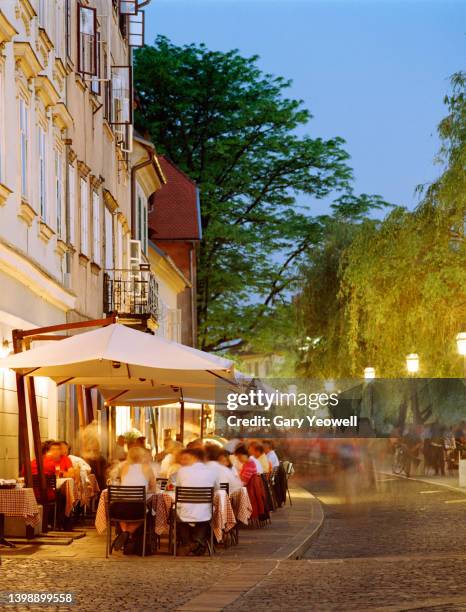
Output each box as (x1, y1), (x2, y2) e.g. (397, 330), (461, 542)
(0, 323), (234, 388)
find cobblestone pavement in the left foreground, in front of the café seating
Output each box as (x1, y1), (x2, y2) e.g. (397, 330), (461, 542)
(0, 557), (238, 612)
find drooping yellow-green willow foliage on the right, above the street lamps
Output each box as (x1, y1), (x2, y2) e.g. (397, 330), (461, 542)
(300, 73), (466, 377)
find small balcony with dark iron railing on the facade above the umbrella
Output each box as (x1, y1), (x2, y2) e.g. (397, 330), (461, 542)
(104, 264), (158, 329)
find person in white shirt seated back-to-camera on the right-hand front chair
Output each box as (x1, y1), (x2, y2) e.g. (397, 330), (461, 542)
(176, 448), (220, 556)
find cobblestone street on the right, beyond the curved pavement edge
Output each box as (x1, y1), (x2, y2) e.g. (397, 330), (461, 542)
(226, 477), (466, 612)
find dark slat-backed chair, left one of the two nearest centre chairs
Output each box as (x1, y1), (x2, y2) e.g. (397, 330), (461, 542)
(105, 486), (147, 559)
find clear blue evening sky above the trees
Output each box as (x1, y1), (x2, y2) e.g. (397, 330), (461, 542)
(146, 0), (466, 213)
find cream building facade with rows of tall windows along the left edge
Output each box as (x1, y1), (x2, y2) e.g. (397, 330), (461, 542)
(0, 0), (153, 476)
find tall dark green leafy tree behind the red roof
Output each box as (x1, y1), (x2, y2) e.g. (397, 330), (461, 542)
(134, 37), (378, 350)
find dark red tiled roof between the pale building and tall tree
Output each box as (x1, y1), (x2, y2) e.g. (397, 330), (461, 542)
(149, 155), (202, 241)
